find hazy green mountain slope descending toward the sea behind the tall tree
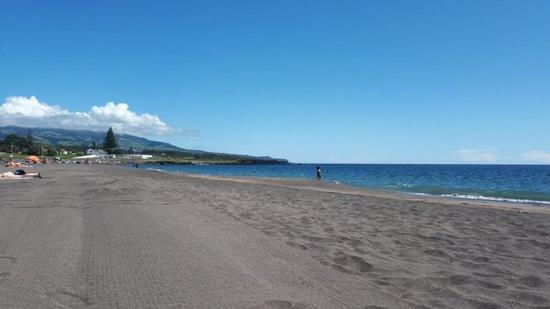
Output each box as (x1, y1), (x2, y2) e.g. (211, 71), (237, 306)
(0, 126), (288, 163)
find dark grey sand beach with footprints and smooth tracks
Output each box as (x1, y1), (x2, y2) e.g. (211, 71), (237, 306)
(0, 165), (550, 309)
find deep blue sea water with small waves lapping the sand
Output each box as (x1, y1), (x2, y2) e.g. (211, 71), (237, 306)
(141, 164), (550, 206)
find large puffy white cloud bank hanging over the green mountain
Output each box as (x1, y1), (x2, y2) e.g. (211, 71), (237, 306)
(0, 96), (183, 135)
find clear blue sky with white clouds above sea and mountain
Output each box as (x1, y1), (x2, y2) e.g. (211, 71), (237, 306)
(0, 1), (550, 163)
